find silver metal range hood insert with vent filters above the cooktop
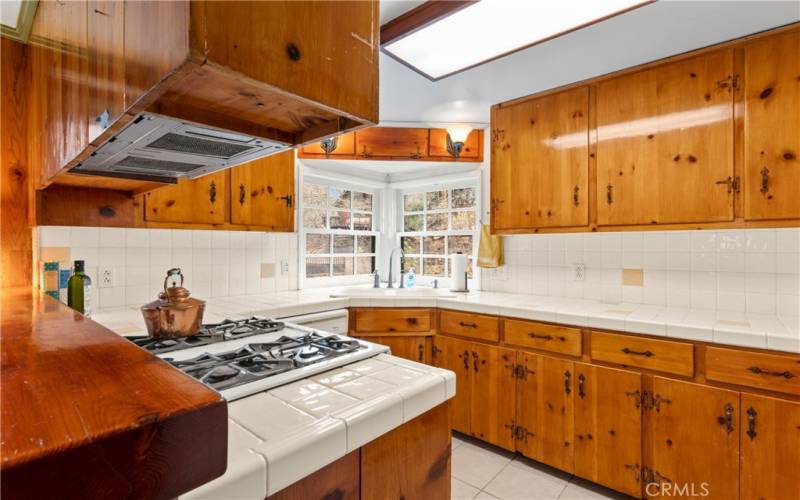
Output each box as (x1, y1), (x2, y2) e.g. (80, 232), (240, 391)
(70, 113), (290, 183)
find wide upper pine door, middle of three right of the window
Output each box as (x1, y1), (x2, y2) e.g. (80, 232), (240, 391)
(596, 49), (734, 225)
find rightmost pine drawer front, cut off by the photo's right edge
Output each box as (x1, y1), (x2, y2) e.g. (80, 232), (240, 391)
(706, 347), (800, 394)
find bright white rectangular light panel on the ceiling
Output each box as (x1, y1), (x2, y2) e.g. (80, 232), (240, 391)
(383, 0), (650, 80)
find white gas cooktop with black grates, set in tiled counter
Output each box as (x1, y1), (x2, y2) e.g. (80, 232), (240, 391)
(127, 317), (389, 401)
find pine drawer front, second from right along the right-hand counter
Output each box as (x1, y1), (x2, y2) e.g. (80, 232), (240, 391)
(592, 331), (694, 377)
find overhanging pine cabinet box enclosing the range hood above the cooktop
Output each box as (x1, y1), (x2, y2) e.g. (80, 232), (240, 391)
(31, 0), (378, 190)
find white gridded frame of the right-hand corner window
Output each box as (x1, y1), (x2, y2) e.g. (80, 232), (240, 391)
(395, 180), (481, 289)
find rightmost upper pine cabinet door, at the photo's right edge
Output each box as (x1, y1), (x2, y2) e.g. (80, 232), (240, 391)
(744, 31), (800, 220)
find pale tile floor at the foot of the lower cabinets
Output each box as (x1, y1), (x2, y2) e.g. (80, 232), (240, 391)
(451, 433), (630, 500)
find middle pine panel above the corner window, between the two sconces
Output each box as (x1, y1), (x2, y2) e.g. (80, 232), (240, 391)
(356, 127), (428, 160)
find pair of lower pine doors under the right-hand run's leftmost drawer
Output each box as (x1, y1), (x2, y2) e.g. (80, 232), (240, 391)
(434, 335), (516, 450)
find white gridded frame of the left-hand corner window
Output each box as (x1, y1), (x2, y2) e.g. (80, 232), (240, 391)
(298, 174), (383, 288)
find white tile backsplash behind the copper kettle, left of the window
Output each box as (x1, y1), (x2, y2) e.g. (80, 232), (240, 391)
(39, 226), (298, 310)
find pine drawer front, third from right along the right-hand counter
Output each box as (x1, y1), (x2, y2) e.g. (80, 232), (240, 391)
(504, 319), (583, 356)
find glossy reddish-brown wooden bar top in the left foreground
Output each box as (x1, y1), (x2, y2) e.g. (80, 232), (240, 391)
(0, 289), (228, 498)
